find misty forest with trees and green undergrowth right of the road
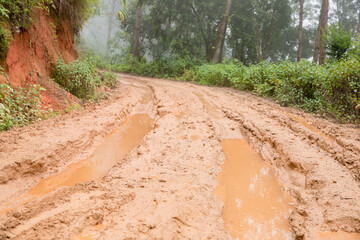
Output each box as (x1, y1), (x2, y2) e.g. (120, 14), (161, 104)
(79, 0), (360, 121)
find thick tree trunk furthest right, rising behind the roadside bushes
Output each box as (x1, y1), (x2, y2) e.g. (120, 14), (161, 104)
(313, 0), (329, 65)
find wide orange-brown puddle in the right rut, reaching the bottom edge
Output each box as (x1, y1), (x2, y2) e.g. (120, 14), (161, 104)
(216, 139), (294, 240)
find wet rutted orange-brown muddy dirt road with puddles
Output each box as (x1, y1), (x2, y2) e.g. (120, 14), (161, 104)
(0, 75), (360, 240)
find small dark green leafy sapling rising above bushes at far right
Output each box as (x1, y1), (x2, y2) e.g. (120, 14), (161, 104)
(326, 24), (352, 60)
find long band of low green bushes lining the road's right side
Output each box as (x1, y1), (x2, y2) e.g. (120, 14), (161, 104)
(100, 55), (360, 121)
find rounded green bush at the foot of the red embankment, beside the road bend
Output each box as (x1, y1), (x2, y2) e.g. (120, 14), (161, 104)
(52, 59), (101, 99)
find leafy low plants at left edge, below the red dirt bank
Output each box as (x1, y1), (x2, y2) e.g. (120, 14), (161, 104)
(0, 84), (49, 131)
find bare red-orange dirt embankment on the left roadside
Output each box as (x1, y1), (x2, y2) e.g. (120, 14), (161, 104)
(5, 9), (76, 110)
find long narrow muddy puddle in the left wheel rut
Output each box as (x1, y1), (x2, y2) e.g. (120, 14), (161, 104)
(0, 114), (154, 214)
